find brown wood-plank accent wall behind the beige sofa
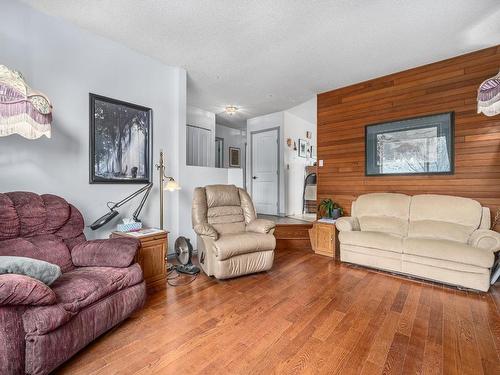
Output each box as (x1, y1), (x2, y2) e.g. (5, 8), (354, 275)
(318, 46), (500, 223)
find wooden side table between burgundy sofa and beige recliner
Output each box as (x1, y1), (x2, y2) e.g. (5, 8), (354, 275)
(110, 231), (168, 292)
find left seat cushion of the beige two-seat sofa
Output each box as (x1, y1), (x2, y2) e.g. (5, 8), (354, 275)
(339, 231), (403, 254)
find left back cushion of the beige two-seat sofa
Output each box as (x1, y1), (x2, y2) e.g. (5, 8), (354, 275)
(352, 193), (411, 236)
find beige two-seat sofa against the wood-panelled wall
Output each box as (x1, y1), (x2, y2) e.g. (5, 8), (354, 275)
(336, 193), (500, 291)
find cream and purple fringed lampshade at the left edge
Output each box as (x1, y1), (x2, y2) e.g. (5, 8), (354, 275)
(0, 65), (52, 139)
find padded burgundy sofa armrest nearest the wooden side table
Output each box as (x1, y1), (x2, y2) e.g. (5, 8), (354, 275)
(71, 237), (140, 268)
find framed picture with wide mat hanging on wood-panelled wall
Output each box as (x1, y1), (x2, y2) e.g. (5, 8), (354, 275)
(365, 112), (454, 176)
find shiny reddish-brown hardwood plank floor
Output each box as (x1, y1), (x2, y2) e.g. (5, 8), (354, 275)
(58, 250), (500, 375)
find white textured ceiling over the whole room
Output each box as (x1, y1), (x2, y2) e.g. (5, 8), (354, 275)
(23, 0), (500, 126)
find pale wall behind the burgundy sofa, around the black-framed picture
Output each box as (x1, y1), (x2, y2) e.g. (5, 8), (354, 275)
(0, 1), (186, 250)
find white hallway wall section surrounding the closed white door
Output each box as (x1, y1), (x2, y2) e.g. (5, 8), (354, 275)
(246, 112), (286, 215)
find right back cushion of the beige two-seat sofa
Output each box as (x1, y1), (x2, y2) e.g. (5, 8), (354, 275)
(408, 194), (483, 243)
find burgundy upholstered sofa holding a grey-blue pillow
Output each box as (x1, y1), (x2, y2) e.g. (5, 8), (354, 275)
(0, 192), (146, 374)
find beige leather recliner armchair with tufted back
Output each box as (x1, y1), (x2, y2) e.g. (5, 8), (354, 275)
(192, 185), (276, 279)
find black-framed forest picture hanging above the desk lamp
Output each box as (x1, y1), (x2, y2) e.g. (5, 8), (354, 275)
(89, 94), (152, 184)
